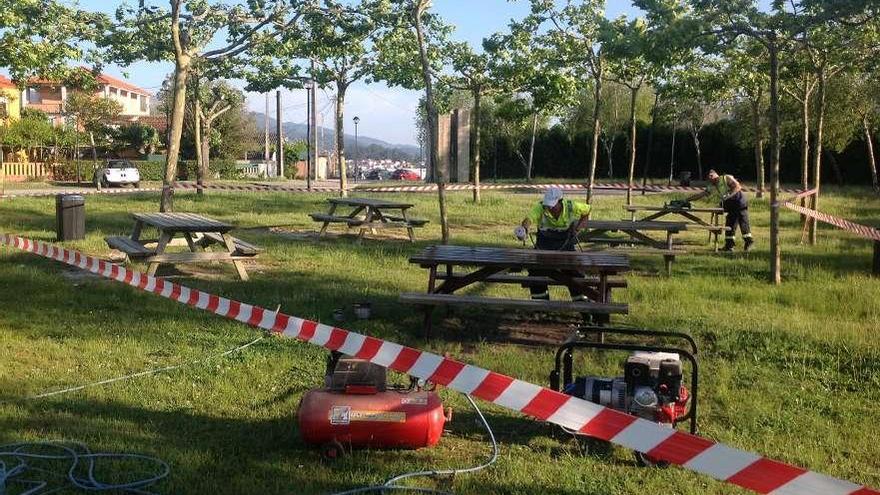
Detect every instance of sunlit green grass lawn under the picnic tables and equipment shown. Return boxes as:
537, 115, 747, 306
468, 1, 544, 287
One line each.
0, 189, 880, 495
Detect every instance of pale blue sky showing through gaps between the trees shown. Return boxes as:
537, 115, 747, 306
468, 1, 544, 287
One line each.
72, 0, 634, 144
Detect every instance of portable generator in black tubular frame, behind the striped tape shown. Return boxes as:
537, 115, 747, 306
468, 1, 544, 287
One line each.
550, 327, 699, 466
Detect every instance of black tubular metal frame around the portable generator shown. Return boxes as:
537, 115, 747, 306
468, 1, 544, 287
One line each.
550, 326, 700, 435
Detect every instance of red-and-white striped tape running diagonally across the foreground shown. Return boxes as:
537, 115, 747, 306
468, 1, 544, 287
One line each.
0, 234, 880, 495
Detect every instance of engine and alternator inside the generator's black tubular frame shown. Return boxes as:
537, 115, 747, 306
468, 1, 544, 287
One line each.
564, 351, 690, 427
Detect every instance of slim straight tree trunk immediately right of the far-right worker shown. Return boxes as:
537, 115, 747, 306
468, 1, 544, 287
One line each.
768, 41, 782, 285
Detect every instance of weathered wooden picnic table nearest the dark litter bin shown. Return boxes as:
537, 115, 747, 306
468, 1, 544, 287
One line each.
105, 213, 260, 280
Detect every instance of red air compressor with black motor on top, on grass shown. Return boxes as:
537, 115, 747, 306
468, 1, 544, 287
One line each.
297, 352, 446, 459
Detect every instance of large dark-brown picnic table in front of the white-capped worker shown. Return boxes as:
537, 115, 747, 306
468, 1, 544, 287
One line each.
400, 245, 630, 337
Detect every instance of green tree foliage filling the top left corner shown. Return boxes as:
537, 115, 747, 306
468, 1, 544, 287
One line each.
0, 0, 109, 87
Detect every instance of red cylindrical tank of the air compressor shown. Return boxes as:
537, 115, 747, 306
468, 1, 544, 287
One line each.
297, 390, 446, 449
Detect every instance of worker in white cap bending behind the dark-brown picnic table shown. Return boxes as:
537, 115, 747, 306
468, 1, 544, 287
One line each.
514, 187, 591, 301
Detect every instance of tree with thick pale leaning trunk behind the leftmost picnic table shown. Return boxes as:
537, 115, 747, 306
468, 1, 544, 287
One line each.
108, 0, 317, 211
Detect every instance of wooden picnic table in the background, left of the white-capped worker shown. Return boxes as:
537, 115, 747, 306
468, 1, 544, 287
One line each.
309, 198, 428, 242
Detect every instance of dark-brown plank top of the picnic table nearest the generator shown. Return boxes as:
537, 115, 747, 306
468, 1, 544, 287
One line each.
409, 245, 629, 273
